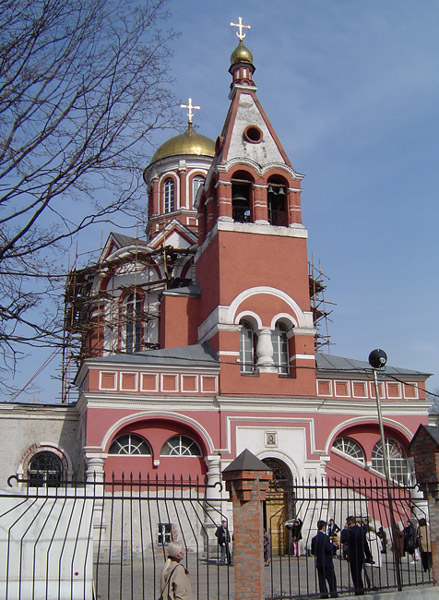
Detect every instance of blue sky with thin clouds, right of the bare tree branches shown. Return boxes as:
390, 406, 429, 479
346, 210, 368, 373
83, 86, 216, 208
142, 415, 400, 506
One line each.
6, 0, 439, 400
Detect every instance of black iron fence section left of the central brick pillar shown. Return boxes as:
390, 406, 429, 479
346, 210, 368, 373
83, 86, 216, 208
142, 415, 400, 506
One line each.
0, 477, 233, 600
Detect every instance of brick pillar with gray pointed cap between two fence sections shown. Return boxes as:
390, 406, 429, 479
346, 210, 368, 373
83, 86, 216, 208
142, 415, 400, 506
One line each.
222, 450, 273, 600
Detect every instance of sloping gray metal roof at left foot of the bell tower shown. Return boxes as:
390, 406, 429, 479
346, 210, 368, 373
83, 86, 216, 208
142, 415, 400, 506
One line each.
85, 343, 219, 369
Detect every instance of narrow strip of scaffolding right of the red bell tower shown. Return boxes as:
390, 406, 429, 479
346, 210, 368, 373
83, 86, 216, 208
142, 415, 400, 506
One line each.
308, 256, 336, 354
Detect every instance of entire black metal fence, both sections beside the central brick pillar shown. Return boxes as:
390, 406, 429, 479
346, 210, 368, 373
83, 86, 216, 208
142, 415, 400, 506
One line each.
0, 477, 432, 600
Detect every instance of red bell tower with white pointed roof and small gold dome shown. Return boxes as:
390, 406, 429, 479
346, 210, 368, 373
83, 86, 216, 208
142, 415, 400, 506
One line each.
195, 18, 315, 395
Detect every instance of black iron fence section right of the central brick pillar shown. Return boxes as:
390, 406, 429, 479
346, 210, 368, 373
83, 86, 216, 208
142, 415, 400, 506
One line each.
265, 479, 433, 599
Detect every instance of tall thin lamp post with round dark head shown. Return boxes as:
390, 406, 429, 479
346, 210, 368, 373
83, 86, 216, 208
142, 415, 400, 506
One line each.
369, 348, 402, 591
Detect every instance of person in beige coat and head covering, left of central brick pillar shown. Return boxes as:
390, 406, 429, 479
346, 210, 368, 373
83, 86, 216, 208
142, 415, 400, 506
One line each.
160, 542, 192, 600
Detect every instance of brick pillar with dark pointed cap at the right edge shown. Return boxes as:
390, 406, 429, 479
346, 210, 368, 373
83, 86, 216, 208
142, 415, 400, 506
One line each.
409, 425, 439, 585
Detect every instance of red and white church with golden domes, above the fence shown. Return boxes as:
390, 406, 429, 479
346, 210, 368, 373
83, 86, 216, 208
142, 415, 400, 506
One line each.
2, 21, 434, 536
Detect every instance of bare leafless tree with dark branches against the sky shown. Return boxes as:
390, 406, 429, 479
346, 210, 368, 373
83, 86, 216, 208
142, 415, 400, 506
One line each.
0, 0, 179, 384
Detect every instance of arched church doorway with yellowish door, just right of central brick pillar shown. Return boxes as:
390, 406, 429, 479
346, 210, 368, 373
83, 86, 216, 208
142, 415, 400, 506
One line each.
263, 458, 295, 555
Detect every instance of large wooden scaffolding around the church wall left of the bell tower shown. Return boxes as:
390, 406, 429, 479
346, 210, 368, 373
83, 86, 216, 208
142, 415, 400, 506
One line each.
61, 238, 195, 403
